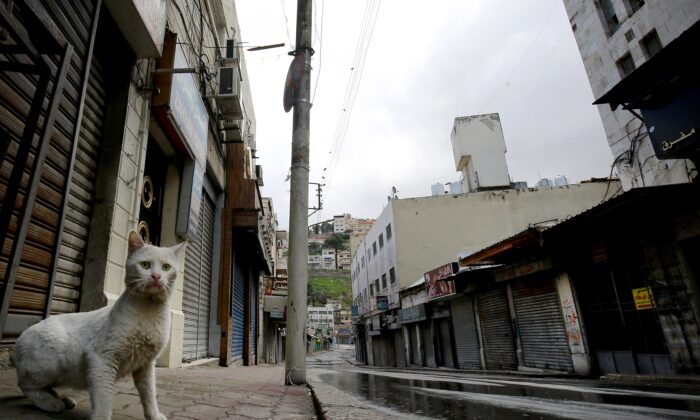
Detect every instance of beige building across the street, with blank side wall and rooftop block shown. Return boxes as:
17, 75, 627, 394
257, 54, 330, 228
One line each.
351, 115, 618, 361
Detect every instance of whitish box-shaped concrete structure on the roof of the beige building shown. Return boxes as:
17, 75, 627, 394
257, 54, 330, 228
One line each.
451, 114, 510, 192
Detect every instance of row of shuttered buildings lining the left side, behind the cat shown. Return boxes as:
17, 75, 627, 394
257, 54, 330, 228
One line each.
0, 0, 270, 367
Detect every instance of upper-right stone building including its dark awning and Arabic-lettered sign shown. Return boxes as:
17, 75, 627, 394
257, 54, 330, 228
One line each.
564, 0, 700, 191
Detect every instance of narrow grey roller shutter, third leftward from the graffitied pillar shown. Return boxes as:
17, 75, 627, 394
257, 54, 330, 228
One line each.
452, 296, 481, 369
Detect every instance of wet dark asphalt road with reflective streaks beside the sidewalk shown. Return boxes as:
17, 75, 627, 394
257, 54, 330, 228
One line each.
307, 348, 700, 420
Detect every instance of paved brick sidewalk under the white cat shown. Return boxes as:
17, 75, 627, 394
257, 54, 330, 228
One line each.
0, 364, 317, 420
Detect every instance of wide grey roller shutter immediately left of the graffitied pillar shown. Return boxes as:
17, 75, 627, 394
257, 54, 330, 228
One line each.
512, 279, 573, 371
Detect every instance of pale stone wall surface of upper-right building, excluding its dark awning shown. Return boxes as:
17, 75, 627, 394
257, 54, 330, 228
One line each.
564, 0, 700, 191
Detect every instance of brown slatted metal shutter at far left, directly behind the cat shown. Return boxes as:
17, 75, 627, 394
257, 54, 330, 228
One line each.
0, 1, 107, 342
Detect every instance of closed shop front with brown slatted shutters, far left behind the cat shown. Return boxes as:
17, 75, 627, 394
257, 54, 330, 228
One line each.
0, 1, 133, 343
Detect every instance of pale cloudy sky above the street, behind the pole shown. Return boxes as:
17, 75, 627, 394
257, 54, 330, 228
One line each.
236, 0, 612, 229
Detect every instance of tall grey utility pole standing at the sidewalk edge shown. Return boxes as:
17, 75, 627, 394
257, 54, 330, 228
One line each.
285, 0, 313, 385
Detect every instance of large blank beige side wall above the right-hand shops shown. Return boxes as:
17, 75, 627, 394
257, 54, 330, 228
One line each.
393, 182, 619, 287
